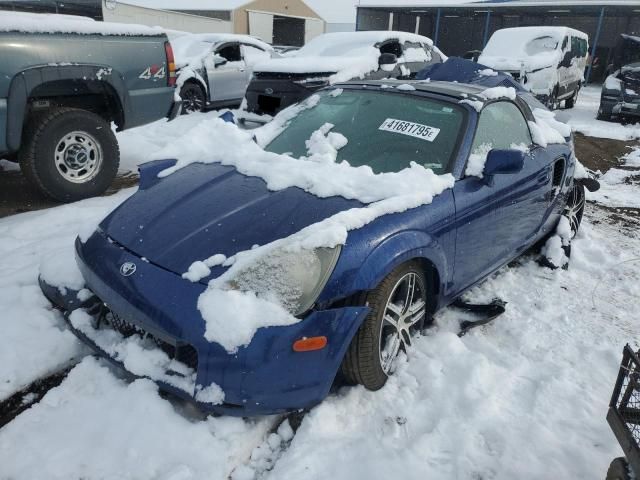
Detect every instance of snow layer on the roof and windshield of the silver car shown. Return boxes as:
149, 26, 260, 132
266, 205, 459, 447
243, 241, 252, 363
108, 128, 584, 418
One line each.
171, 33, 273, 68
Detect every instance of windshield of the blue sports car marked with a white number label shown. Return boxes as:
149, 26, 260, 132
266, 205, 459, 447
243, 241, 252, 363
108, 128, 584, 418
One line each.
266, 90, 464, 174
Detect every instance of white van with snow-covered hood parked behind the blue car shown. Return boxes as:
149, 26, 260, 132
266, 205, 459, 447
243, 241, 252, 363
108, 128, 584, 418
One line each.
478, 27, 589, 110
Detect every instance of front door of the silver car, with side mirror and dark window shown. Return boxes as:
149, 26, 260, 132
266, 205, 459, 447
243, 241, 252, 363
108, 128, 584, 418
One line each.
207, 42, 247, 102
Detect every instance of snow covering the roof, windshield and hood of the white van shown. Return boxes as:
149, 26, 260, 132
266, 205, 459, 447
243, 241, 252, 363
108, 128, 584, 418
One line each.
478, 27, 588, 70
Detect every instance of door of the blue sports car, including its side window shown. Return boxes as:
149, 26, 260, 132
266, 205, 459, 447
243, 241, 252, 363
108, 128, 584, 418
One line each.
453, 101, 550, 291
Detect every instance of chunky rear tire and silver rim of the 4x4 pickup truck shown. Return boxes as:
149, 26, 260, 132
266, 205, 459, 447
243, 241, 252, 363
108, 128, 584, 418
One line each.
18, 108, 120, 202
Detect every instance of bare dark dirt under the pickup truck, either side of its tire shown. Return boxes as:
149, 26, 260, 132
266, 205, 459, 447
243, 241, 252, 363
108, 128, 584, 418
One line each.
0, 165, 138, 218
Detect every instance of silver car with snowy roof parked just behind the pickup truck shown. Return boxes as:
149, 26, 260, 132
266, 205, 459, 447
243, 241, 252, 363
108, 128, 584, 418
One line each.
171, 33, 275, 113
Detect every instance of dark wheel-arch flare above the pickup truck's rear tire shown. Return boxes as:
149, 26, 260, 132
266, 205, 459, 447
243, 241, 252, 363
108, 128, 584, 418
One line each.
7, 64, 130, 151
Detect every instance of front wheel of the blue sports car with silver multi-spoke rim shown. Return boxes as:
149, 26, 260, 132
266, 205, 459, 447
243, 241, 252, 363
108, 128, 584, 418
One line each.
341, 261, 428, 390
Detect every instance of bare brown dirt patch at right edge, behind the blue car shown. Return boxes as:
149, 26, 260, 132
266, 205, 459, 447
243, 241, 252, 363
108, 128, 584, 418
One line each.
575, 133, 640, 173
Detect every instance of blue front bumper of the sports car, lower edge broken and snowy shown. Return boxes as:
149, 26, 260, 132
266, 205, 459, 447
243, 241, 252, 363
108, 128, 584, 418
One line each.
42, 233, 368, 416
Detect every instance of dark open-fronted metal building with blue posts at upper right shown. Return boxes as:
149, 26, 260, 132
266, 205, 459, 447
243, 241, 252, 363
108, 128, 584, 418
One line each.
356, 0, 640, 81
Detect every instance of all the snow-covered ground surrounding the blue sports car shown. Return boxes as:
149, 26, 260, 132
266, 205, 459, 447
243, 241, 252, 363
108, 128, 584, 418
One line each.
0, 89, 640, 480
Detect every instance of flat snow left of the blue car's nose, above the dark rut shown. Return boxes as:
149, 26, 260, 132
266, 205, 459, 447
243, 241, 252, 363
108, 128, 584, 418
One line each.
0, 189, 134, 402
